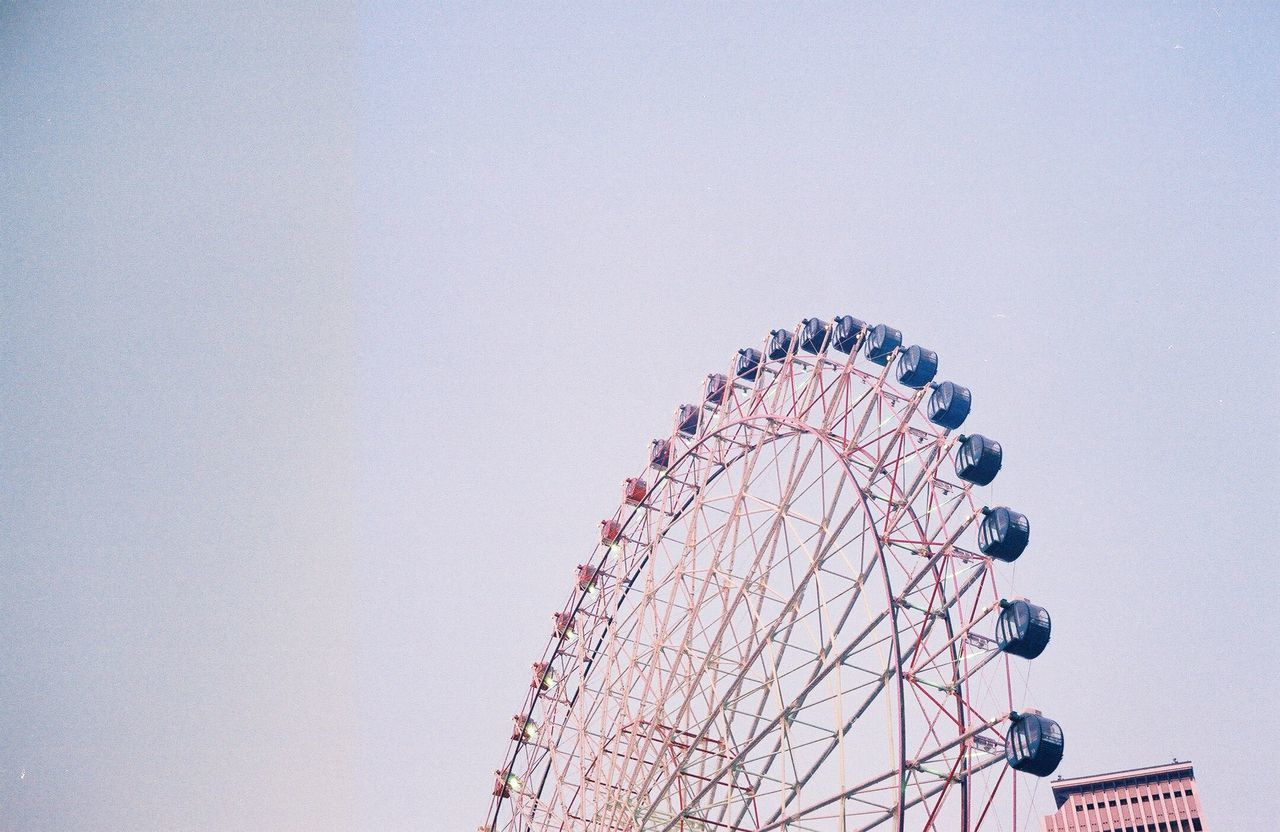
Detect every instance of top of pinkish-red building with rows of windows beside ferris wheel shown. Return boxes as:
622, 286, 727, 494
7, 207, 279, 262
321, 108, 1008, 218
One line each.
1043, 762, 1204, 832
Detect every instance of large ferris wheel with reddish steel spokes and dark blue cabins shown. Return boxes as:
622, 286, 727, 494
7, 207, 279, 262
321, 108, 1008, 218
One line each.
480, 316, 1064, 832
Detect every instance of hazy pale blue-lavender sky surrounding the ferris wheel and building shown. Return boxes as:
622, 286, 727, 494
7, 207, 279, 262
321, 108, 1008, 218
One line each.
0, 3, 1280, 831
